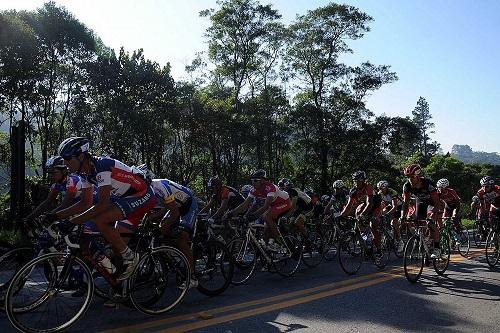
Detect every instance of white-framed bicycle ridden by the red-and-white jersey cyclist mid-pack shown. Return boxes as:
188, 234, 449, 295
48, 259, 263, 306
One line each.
228, 217, 303, 285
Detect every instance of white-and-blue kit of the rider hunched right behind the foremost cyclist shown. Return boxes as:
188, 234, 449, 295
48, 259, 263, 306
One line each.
151, 179, 198, 231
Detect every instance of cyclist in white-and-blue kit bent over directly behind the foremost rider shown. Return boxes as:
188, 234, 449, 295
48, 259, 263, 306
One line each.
146, 171, 198, 288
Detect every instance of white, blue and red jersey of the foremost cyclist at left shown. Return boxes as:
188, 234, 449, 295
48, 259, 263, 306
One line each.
81, 156, 148, 198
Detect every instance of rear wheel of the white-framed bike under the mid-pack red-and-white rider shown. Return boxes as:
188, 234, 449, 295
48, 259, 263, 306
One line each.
271, 235, 304, 277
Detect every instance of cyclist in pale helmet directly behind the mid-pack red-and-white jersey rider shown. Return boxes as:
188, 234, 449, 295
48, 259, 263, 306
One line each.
278, 178, 314, 242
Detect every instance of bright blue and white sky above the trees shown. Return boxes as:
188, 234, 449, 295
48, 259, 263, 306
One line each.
0, 0, 500, 152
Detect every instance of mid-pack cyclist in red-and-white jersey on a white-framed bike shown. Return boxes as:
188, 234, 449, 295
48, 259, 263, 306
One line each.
227, 169, 292, 250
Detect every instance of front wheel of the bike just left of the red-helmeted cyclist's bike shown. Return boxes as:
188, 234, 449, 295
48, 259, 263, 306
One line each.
339, 231, 365, 275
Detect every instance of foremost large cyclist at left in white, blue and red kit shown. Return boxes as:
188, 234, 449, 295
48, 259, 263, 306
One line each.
50, 137, 156, 281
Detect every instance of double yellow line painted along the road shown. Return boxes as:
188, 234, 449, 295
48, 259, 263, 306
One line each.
102, 252, 483, 333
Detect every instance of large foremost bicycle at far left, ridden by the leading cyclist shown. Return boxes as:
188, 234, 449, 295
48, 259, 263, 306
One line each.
5, 223, 191, 332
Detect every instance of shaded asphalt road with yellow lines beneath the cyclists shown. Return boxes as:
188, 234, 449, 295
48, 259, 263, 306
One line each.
0, 245, 500, 333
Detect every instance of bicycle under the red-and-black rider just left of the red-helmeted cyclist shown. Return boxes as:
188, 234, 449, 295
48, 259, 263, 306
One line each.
339, 217, 390, 275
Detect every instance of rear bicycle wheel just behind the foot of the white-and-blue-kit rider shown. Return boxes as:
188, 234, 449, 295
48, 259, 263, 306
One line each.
193, 241, 234, 296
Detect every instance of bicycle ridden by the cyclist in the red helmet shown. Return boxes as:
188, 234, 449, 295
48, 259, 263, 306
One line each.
403, 220, 451, 283
